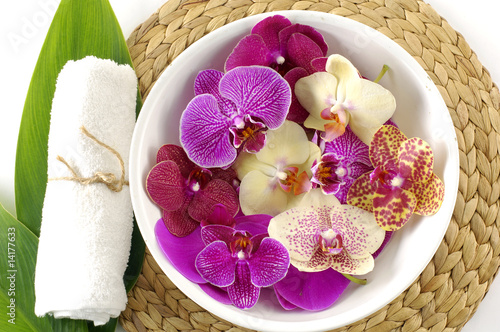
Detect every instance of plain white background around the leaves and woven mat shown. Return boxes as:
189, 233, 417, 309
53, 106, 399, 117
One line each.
0, 0, 500, 332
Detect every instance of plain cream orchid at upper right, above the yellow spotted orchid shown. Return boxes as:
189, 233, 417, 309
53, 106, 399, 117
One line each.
295, 54, 396, 145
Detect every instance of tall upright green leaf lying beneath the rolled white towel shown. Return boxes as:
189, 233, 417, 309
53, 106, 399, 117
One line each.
15, 0, 145, 331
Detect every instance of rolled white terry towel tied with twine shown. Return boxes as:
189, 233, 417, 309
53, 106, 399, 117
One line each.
35, 57, 137, 325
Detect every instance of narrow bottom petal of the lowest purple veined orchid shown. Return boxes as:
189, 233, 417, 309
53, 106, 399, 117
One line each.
227, 261, 260, 309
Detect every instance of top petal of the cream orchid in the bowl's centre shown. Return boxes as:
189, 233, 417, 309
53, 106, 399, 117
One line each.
255, 121, 310, 167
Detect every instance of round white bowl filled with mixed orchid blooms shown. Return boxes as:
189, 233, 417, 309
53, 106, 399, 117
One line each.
130, 11, 458, 331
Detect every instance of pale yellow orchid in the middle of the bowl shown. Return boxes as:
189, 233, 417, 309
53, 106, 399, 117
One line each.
233, 121, 320, 216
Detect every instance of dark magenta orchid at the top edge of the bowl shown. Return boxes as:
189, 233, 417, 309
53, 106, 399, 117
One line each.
225, 15, 328, 74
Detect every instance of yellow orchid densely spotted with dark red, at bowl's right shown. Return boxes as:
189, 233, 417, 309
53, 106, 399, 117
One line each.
347, 126, 444, 231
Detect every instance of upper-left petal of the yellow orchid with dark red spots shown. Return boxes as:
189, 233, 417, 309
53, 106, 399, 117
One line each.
370, 125, 408, 167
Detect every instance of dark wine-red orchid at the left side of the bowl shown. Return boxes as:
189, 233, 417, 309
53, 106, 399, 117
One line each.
146, 144, 239, 237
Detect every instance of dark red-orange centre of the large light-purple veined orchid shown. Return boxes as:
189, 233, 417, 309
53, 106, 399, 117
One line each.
229, 115, 267, 153
